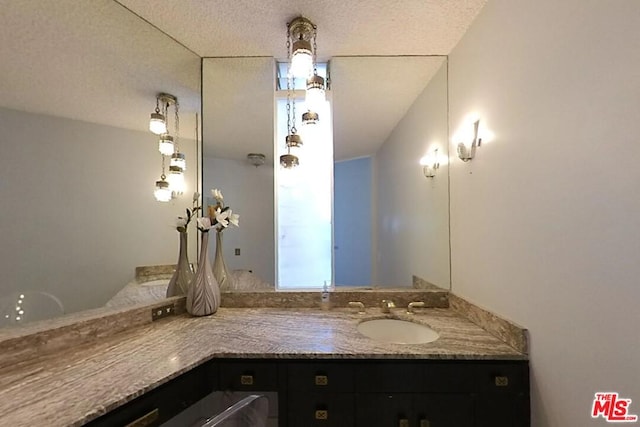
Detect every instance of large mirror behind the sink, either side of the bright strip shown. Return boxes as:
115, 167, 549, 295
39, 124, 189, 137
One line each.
202, 56, 450, 289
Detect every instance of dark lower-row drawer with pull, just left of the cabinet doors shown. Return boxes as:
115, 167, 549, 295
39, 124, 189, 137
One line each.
288, 392, 355, 427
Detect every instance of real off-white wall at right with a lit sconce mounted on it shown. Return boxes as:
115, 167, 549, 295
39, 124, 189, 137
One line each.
449, 0, 640, 427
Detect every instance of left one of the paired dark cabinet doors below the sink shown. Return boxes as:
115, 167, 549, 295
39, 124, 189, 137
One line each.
355, 393, 415, 427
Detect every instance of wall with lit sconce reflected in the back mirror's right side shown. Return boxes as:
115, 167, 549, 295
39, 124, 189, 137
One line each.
374, 63, 450, 288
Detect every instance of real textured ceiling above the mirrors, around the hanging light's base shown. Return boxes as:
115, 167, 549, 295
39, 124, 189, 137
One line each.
118, 0, 486, 59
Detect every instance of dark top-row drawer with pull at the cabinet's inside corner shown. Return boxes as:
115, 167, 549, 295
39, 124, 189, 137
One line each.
219, 361, 278, 391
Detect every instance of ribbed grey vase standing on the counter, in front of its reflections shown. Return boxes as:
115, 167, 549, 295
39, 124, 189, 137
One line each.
186, 231, 220, 316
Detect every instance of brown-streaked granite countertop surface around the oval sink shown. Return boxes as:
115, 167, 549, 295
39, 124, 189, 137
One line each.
0, 308, 527, 427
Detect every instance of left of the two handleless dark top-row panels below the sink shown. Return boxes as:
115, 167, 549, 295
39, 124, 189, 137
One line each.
355, 361, 424, 393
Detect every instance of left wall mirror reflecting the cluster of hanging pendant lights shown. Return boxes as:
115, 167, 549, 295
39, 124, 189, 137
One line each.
0, 0, 200, 327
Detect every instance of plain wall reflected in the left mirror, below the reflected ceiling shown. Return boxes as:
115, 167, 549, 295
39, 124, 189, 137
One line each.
0, 105, 197, 312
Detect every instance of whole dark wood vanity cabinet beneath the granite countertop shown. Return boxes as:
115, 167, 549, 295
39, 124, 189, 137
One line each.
91, 359, 530, 427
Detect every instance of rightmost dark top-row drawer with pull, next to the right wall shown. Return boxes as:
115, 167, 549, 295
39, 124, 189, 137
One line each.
476, 363, 529, 392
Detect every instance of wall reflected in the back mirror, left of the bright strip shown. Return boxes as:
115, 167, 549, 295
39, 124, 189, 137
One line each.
203, 157, 275, 283
